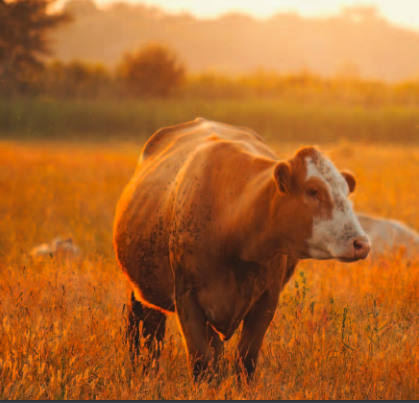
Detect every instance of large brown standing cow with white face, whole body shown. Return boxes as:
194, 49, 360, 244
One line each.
113, 118, 370, 381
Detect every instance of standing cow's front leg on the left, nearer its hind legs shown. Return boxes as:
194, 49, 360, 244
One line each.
175, 281, 222, 381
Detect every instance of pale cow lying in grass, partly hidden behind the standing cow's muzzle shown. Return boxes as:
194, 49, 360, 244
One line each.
356, 213, 419, 256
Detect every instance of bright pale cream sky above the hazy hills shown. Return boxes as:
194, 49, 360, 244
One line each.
83, 0, 419, 30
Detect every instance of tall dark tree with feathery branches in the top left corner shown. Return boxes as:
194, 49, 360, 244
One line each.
0, 0, 71, 92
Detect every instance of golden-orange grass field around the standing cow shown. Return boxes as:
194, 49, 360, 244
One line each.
0, 137, 419, 399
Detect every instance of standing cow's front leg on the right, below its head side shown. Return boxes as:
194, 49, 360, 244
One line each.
237, 291, 279, 382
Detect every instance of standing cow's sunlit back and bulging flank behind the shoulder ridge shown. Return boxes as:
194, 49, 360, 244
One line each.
114, 118, 275, 310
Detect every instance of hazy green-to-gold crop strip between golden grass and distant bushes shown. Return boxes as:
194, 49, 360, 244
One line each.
0, 98, 419, 144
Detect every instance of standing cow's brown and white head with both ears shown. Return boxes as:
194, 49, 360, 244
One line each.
274, 147, 371, 262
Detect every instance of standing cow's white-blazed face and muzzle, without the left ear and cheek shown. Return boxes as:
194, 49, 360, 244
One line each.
304, 153, 371, 262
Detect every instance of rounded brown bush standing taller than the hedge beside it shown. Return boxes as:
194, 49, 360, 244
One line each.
118, 44, 185, 97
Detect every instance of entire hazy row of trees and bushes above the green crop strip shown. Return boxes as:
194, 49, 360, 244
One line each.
0, 0, 419, 106
